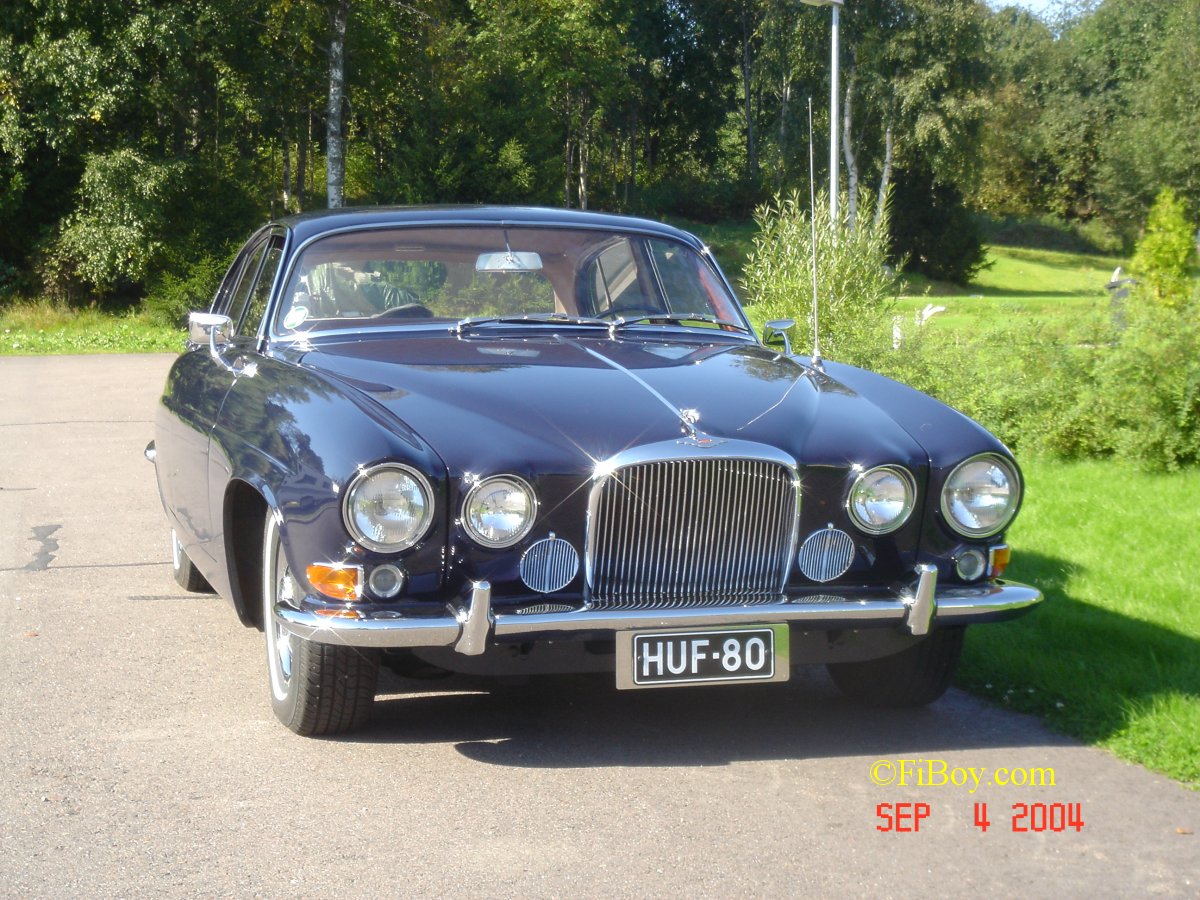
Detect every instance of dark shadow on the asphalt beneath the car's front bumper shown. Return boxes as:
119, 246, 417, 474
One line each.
340, 667, 1074, 768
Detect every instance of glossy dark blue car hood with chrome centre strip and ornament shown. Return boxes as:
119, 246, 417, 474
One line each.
300, 331, 928, 476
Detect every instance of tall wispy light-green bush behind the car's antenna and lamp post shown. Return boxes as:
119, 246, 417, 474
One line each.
742, 193, 899, 366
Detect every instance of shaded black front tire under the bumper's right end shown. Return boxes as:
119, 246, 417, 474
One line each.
826, 628, 966, 707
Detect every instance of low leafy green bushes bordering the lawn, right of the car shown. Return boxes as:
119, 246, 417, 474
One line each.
876, 288, 1200, 470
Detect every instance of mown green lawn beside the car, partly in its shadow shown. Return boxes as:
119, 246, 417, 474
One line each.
959, 460, 1200, 788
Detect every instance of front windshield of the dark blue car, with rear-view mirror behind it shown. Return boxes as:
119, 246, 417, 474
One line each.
275, 226, 744, 335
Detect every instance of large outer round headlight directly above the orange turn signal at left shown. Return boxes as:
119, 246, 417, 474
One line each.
342, 463, 433, 553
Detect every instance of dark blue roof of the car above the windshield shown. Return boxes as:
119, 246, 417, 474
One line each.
272, 206, 703, 250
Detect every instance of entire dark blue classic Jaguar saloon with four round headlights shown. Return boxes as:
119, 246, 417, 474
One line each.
146, 208, 1042, 734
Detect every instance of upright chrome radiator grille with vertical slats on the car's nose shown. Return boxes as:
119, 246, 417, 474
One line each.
587, 458, 798, 608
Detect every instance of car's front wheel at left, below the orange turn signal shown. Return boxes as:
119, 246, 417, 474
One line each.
263, 514, 379, 736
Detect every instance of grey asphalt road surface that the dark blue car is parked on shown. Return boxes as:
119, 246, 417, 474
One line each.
0, 356, 1200, 896
